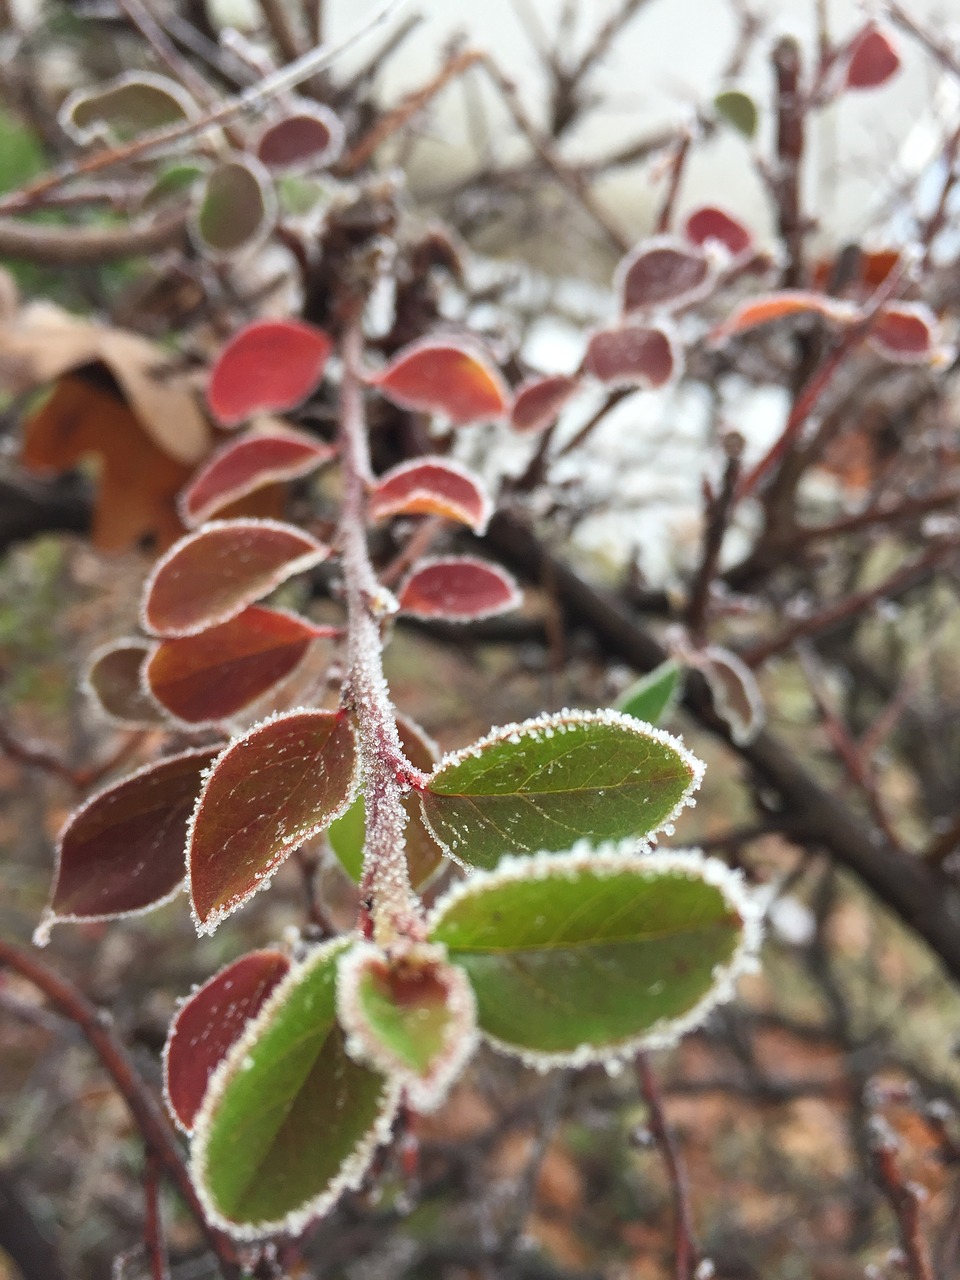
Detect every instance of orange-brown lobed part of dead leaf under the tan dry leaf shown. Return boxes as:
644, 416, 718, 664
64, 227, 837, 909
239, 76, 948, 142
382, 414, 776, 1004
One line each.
20, 374, 189, 552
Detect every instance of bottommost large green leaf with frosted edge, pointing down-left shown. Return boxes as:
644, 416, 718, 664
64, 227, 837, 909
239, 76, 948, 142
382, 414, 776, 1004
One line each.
191, 938, 399, 1239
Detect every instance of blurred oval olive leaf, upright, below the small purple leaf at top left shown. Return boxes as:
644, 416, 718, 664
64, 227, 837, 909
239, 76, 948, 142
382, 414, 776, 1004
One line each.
192, 155, 278, 259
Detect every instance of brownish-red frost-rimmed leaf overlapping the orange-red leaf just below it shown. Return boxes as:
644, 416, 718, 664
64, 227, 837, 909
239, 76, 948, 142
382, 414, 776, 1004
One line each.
141, 520, 329, 636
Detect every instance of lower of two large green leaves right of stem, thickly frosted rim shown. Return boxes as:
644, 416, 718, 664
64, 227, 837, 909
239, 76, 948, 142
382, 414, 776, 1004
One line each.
428, 847, 760, 1071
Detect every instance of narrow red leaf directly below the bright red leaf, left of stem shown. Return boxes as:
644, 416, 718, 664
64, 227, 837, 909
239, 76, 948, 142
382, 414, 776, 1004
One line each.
178, 431, 337, 529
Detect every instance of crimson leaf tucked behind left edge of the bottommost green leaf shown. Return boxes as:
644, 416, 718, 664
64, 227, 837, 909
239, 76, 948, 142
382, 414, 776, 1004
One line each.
164, 951, 291, 1133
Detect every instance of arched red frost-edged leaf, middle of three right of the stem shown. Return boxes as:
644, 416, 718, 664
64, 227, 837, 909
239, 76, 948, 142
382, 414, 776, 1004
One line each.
370, 458, 493, 534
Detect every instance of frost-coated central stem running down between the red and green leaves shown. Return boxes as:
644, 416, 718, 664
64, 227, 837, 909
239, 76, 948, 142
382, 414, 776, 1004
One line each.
339, 325, 425, 945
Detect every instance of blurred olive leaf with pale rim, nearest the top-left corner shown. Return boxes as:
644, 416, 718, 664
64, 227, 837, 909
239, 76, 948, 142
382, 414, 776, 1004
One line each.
58, 72, 198, 146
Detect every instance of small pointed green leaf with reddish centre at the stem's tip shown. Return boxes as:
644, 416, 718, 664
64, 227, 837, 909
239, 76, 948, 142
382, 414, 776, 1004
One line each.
337, 942, 476, 1112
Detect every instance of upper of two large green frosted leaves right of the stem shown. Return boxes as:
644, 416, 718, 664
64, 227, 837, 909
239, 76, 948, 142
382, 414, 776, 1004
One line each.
420, 710, 703, 869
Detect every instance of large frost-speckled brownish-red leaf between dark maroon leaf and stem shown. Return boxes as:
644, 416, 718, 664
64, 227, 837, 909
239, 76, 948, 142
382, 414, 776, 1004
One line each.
187, 710, 356, 933
